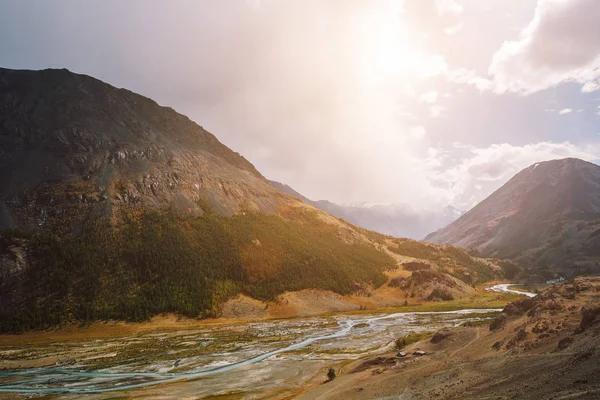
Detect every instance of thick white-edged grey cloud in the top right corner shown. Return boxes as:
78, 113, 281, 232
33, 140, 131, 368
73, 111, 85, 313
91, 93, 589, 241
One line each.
488, 0, 600, 94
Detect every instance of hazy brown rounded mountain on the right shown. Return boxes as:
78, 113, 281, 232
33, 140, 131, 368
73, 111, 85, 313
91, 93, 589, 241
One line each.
425, 158, 600, 275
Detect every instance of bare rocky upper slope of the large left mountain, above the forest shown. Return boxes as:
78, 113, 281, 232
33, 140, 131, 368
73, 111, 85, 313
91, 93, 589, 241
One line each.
0, 69, 279, 230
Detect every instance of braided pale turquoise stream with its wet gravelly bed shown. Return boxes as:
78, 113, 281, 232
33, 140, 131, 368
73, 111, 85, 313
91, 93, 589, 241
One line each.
0, 285, 535, 398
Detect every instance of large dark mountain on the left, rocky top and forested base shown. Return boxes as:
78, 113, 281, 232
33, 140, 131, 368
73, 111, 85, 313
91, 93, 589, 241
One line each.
0, 69, 504, 332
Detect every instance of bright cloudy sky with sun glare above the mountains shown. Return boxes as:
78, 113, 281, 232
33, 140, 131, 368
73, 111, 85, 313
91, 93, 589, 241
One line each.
0, 0, 600, 210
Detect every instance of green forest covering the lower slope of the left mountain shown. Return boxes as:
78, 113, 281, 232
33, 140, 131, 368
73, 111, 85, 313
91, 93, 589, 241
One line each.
0, 210, 395, 333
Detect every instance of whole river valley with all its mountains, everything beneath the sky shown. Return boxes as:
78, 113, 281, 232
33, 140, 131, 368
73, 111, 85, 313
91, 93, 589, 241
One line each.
0, 68, 600, 400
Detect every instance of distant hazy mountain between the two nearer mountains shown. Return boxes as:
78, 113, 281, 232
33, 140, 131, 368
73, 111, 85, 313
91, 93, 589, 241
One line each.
269, 181, 462, 239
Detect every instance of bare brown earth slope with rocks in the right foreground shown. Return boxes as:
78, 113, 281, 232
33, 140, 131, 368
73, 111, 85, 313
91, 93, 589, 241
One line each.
299, 277, 600, 400
